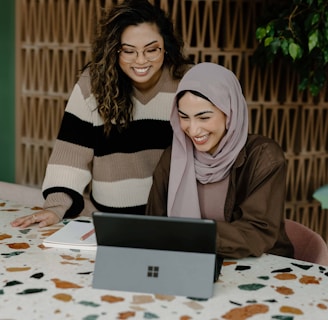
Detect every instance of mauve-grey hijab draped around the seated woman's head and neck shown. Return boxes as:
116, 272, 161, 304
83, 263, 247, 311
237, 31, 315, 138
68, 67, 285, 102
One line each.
167, 62, 248, 218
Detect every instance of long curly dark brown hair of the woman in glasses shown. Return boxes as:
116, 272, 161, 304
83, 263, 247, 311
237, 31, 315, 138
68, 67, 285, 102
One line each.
87, 0, 191, 135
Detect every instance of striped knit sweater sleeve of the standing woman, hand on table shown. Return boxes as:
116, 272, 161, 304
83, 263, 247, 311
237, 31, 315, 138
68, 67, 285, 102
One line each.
42, 79, 100, 217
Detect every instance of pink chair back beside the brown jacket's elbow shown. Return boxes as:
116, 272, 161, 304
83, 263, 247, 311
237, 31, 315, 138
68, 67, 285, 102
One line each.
285, 219, 328, 266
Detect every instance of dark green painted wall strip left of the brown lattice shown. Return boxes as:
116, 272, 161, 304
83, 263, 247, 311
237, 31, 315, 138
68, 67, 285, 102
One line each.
0, 0, 15, 182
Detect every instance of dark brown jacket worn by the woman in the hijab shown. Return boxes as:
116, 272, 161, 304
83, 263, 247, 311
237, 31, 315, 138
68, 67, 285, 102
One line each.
146, 135, 293, 258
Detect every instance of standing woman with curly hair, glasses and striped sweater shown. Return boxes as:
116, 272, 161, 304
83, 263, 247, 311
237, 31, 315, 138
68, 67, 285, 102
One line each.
12, 0, 190, 227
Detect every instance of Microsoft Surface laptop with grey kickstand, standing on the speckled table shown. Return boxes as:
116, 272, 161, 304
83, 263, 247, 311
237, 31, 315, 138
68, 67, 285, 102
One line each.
92, 212, 222, 299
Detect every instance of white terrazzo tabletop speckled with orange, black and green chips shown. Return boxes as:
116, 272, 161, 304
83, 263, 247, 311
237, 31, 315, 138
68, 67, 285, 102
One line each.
0, 200, 328, 320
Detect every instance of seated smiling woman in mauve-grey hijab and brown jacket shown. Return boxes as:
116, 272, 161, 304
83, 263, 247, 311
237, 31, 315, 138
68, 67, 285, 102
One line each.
146, 62, 293, 258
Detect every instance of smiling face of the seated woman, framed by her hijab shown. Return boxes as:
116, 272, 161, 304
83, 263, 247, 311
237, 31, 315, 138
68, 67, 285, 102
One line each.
178, 92, 227, 154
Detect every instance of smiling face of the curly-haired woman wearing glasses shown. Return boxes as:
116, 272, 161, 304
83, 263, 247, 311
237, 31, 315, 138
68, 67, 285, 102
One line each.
119, 23, 165, 90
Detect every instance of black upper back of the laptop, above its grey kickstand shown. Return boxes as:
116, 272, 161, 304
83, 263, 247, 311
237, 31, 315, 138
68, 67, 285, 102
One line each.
93, 212, 216, 253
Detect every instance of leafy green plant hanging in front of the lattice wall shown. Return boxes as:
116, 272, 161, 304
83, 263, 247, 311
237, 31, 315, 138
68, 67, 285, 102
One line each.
254, 0, 328, 96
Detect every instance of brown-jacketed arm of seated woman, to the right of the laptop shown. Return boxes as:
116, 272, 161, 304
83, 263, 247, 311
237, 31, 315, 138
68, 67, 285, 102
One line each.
217, 139, 289, 258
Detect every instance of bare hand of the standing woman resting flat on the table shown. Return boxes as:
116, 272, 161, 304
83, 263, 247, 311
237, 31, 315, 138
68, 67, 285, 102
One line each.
11, 210, 60, 228
